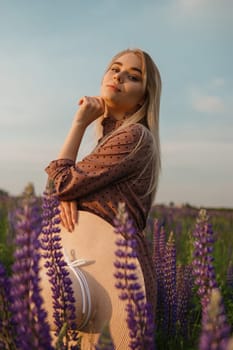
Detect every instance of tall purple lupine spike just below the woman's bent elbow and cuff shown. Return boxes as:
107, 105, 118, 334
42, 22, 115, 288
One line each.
40, 183, 77, 345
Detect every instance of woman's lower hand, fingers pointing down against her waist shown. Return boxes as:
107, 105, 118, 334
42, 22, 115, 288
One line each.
60, 201, 78, 232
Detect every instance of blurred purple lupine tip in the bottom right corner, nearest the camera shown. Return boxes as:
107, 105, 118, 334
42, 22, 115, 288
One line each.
199, 288, 230, 350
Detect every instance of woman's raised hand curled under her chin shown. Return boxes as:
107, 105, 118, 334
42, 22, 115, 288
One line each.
74, 96, 105, 127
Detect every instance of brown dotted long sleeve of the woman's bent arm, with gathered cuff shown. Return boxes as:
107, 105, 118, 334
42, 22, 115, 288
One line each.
46, 124, 151, 200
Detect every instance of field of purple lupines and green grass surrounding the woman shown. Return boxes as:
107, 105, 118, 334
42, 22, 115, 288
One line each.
0, 185, 233, 350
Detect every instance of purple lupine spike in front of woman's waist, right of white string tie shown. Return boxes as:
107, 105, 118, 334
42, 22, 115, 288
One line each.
114, 203, 155, 350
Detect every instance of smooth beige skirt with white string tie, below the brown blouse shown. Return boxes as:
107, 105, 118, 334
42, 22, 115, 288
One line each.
41, 211, 145, 350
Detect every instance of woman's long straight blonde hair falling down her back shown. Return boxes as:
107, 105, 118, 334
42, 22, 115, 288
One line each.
97, 49, 162, 201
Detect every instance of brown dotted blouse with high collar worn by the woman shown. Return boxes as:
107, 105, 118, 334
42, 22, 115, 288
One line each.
46, 117, 155, 312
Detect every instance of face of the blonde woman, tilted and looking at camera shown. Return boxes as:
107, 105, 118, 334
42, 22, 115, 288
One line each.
101, 52, 145, 118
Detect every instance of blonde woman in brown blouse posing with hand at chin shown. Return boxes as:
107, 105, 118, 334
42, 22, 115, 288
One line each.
43, 49, 161, 349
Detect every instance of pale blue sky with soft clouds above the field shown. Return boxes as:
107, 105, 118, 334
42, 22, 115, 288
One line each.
0, 0, 233, 208
